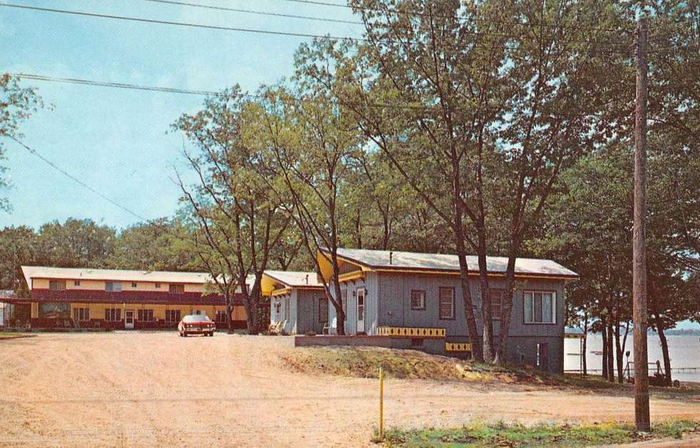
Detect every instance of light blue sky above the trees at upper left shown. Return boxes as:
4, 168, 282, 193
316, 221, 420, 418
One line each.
0, 0, 362, 229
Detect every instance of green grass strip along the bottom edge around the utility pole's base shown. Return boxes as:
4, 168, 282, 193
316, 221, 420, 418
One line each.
373, 420, 700, 448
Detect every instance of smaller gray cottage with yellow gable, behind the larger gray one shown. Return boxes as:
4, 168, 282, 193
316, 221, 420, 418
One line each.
261, 270, 328, 334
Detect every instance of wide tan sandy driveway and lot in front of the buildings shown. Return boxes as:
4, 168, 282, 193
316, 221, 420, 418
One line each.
0, 332, 700, 447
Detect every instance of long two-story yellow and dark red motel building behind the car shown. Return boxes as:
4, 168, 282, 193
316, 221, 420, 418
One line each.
6, 266, 246, 329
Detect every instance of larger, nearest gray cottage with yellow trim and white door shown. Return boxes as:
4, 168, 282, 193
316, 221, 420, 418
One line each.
318, 249, 578, 373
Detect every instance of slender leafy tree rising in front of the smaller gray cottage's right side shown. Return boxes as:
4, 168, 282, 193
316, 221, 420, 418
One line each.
250, 83, 361, 335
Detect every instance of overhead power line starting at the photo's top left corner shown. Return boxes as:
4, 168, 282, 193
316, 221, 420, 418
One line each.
0, 3, 367, 42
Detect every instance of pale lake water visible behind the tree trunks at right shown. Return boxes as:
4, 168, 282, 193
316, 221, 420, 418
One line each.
564, 330, 700, 382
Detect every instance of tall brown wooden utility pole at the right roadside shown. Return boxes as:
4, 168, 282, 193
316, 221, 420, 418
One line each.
632, 10, 651, 432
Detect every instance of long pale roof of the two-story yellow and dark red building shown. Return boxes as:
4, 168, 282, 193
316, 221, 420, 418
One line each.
22, 266, 212, 288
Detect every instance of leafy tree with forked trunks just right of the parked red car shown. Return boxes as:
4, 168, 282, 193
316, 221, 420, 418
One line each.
174, 87, 290, 333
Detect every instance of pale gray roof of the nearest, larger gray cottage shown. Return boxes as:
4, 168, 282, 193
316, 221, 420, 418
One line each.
330, 249, 578, 277
